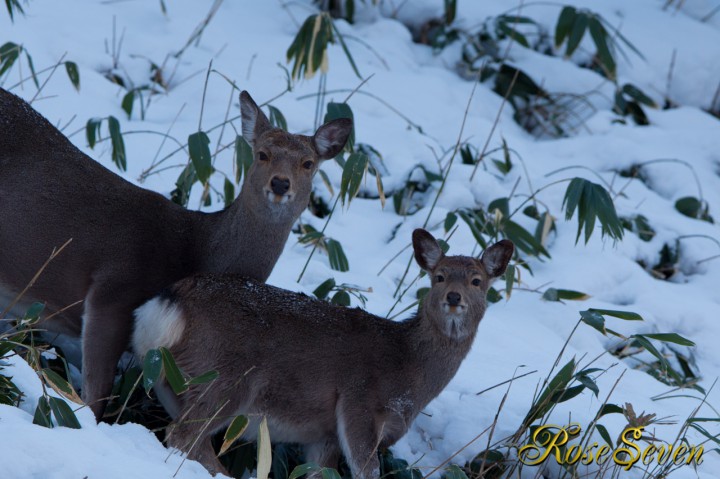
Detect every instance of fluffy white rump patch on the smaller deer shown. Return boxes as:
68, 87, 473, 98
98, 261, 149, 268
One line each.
132, 298, 185, 358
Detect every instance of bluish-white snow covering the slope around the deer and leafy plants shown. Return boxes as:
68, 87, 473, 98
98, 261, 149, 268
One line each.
0, 0, 720, 478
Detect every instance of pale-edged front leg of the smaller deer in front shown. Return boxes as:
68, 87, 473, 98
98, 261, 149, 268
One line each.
336, 401, 380, 479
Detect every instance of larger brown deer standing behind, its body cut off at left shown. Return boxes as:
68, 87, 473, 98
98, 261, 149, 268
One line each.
0, 89, 352, 418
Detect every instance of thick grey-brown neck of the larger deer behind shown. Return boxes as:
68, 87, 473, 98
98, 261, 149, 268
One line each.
199, 188, 295, 282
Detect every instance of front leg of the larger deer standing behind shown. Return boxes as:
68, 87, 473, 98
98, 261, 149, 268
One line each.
82, 289, 135, 421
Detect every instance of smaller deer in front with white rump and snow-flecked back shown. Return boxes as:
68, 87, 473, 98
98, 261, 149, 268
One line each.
133, 229, 514, 479
